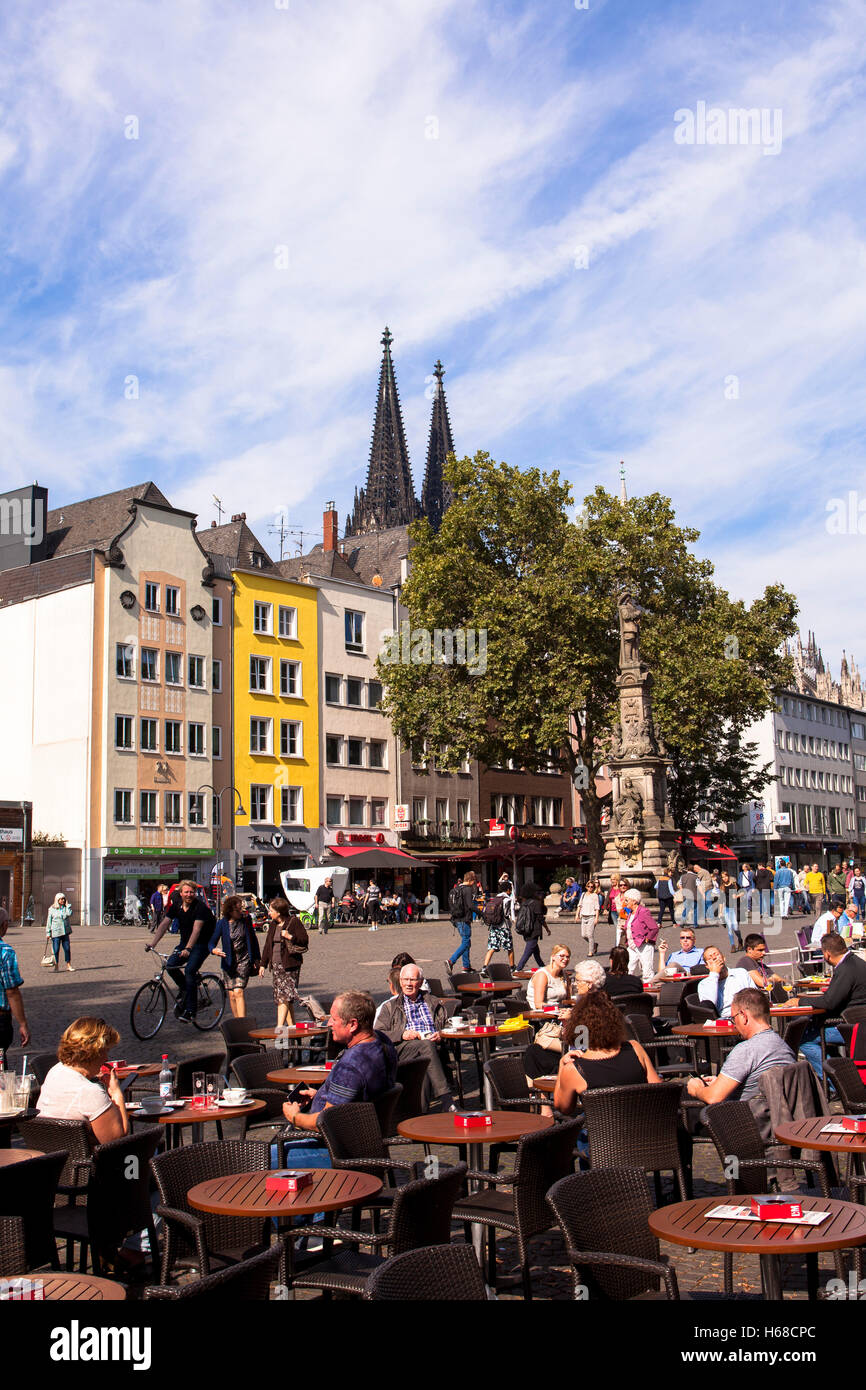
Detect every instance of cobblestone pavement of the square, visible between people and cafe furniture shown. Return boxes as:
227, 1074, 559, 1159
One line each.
1, 917, 835, 1300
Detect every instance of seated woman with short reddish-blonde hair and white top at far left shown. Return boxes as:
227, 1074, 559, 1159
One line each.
36, 1019, 129, 1144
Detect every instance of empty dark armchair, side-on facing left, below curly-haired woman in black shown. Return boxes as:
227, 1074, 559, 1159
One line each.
455, 1120, 581, 1300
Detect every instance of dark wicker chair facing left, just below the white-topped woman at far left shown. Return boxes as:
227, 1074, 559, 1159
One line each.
54, 1125, 162, 1275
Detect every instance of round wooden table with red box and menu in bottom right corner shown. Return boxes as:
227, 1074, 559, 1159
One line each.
649, 1195, 866, 1301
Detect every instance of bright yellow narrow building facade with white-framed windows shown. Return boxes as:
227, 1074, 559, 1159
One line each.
227, 569, 322, 898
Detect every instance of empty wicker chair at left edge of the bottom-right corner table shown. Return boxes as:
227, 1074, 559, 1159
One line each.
548, 1168, 680, 1301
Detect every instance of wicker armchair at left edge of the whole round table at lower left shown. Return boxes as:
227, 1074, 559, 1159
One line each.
150, 1140, 271, 1284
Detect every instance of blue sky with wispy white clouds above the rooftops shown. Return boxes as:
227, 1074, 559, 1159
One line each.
0, 0, 866, 671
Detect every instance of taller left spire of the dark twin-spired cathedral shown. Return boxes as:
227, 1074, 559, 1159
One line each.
346, 327, 418, 535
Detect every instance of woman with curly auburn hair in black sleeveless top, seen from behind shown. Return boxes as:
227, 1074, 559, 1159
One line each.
553, 990, 662, 1117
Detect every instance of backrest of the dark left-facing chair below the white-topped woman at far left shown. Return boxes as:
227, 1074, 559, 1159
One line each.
88, 1125, 163, 1254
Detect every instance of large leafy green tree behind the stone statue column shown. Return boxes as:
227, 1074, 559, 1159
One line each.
378, 453, 795, 867
